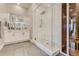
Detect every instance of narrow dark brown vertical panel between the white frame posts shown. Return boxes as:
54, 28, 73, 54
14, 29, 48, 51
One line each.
62, 3, 67, 53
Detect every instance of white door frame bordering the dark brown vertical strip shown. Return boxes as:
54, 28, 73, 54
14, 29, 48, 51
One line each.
60, 3, 69, 56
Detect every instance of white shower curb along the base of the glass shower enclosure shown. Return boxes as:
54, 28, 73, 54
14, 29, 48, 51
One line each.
31, 40, 60, 56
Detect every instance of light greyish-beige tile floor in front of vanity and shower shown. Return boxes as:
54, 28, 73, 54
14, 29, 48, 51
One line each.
0, 42, 48, 56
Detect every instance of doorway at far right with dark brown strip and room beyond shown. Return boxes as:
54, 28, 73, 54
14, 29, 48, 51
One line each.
61, 3, 79, 56
